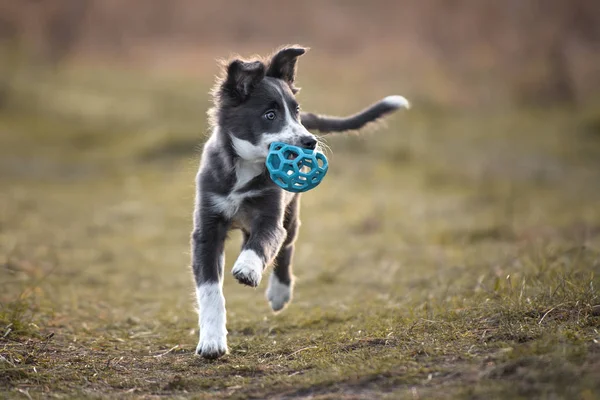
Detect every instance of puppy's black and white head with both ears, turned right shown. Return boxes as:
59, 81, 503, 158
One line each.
212, 46, 317, 162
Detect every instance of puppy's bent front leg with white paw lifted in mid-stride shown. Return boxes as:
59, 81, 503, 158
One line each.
231, 206, 286, 287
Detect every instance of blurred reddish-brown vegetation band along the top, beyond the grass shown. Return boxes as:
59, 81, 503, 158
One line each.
0, 0, 600, 108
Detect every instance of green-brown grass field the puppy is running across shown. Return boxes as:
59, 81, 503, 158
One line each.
0, 66, 600, 399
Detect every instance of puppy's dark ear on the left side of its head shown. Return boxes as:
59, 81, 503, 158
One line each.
221, 59, 265, 103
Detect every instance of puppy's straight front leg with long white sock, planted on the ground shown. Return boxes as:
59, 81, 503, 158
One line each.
192, 209, 228, 358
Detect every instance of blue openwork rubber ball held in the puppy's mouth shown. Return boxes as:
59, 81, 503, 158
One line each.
266, 142, 329, 193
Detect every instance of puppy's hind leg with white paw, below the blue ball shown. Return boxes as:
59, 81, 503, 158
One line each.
265, 195, 300, 312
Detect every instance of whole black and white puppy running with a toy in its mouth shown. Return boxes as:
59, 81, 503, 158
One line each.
191, 46, 408, 358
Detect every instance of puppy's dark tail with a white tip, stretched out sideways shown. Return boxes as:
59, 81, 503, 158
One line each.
300, 96, 410, 133
